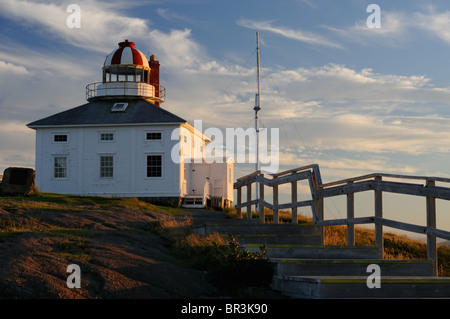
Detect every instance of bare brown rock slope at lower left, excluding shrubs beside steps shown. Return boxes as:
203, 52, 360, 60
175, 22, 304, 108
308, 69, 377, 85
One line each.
0, 194, 215, 299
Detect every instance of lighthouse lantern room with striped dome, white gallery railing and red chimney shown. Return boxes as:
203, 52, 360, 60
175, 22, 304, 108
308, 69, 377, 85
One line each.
86, 40, 165, 106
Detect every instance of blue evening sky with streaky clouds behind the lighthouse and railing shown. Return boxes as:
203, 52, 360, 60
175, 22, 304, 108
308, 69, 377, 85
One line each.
0, 0, 450, 239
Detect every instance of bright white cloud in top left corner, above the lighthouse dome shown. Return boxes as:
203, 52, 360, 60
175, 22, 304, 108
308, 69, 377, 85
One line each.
0, 0, 148, 52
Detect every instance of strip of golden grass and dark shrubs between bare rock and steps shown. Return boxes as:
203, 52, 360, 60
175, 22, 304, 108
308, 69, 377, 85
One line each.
151, 211, 273, 296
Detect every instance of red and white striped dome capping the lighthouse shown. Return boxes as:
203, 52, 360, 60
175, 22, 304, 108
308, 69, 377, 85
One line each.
103, 40, 149, 68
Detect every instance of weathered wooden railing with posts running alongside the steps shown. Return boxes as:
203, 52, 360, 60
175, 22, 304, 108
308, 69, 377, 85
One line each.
234, 164, 450, 275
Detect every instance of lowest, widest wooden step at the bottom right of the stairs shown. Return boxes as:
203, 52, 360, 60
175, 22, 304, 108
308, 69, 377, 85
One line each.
272, 275, 450, 299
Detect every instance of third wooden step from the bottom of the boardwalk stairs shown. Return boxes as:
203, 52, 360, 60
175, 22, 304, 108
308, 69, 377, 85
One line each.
245, 244, 379, 259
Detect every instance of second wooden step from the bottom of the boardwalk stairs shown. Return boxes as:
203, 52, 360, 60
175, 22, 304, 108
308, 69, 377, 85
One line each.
271, 258, 433, 277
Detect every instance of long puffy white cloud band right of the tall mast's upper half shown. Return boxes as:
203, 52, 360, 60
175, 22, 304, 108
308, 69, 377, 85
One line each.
263, 64, 444, 110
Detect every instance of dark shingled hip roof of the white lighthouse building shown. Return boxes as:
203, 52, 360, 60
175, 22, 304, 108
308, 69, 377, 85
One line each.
27, 99, 187, 129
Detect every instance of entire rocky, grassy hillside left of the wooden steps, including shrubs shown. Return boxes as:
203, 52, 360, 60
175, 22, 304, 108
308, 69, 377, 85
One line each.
0, 193, 279, 299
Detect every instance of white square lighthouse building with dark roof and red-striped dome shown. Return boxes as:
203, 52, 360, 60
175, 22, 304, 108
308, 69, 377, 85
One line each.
27, 40, 234, 207
